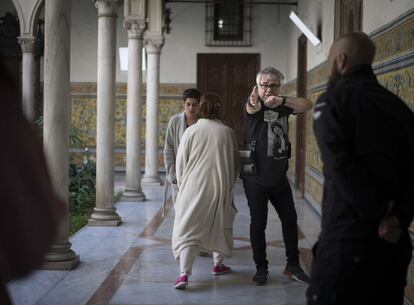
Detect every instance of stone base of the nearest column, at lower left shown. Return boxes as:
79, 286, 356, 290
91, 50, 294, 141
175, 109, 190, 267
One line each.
41, 242, 79, 270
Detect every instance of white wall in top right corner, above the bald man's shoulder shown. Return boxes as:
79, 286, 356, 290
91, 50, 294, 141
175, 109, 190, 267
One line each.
362, 0, 414, 34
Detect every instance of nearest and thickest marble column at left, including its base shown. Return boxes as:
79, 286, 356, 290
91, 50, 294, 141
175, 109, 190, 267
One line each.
43, 0, 79, 270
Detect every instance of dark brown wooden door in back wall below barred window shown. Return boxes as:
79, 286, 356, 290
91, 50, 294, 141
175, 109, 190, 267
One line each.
197, 54, 260, 145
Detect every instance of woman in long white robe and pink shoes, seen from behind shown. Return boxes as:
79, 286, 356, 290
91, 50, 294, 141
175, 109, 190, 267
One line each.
172, 93, 239, 288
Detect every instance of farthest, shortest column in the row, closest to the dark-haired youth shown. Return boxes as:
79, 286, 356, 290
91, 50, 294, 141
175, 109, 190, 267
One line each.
142, 35, 164, 185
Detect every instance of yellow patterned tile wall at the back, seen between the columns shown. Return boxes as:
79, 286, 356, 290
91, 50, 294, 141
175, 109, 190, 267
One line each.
71, 83, 195, 168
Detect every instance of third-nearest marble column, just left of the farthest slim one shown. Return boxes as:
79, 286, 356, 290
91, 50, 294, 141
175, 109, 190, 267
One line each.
123, 19, 145, 201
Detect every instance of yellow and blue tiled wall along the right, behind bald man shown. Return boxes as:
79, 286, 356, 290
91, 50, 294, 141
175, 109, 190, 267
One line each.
286, 10, 414, 302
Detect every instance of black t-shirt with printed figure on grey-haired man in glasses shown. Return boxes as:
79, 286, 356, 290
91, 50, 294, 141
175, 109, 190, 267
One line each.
242, 101, 293, 186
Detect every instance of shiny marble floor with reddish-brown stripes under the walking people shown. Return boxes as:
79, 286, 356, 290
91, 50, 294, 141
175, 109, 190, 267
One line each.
8, 176, 320, 305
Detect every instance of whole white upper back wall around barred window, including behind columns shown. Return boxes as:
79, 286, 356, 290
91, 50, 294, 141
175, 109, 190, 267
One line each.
71, 0, 292, 83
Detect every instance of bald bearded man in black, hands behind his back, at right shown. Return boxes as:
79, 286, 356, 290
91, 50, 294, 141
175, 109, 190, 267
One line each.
307, 33, 414, 305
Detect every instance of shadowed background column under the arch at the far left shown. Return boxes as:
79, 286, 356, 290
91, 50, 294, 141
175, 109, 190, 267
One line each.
19, 34, 36, 123
